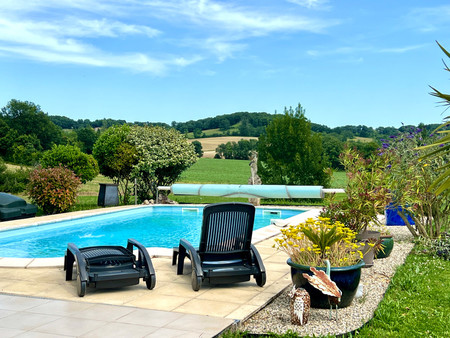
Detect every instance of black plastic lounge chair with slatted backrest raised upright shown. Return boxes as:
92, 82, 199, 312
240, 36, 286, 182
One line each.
172, 203, 266, 291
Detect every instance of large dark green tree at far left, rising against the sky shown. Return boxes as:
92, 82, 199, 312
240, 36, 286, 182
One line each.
1, 100, 62, 150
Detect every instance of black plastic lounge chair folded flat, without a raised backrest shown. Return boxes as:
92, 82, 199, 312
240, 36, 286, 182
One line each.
64, 239, 156, 297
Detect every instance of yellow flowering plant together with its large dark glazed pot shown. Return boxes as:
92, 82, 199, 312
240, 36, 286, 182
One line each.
275, 217, 364, 308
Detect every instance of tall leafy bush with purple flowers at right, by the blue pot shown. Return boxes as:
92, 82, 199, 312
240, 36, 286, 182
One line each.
383, 127, 450, 238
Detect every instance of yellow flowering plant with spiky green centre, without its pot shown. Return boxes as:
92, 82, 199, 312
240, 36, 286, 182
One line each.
275, 217, 363, 267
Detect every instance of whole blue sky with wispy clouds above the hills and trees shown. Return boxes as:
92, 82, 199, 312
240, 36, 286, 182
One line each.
0, 0, 450, 127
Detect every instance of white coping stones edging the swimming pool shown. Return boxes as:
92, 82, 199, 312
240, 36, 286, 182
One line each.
0, 204, 320, 269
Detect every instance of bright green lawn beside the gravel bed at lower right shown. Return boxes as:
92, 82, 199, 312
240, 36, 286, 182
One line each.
221, 253, 450, 338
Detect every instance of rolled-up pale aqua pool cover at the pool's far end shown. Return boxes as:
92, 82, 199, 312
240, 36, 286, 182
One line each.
171, 184, 325, 198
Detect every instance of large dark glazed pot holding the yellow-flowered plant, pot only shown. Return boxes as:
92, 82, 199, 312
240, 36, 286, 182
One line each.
287, 258, 364, 309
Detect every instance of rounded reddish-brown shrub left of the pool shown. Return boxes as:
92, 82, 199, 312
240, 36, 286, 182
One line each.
28, 166, 81, 214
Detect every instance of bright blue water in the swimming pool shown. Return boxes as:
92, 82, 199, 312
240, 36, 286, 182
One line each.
0, 206, 303, 258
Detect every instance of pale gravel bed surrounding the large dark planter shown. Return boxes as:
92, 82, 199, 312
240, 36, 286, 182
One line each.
238, 226, 413, 336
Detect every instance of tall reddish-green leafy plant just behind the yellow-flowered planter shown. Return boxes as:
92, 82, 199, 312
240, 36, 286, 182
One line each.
321, 148, 391, 266
